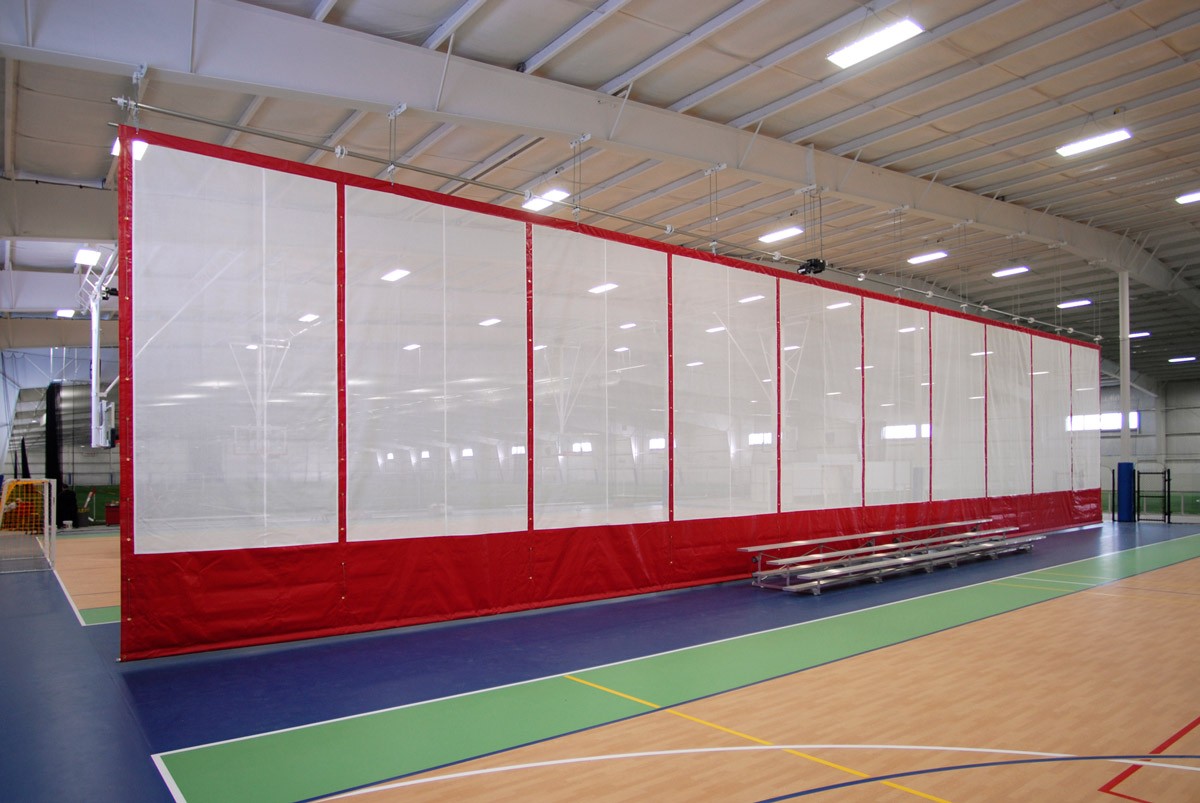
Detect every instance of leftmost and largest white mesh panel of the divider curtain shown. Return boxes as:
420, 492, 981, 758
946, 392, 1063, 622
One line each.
132, 148, 337, 552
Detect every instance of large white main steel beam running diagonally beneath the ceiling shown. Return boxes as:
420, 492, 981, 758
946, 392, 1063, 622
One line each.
0, 0, 1200, 307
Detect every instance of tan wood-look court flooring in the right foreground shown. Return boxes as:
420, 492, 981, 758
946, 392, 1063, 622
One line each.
336, 559, 1200, 803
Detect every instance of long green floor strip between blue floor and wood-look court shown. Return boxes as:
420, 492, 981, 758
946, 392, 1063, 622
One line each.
158, 534, 1200, 803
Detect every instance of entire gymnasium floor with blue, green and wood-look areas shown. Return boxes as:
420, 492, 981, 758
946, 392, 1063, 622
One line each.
0, 522, 1200, 803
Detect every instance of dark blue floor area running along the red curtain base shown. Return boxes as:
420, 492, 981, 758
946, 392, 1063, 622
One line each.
0, 522, 1200, 802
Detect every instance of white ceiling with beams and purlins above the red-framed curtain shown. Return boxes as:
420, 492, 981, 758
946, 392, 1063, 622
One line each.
0, 0, 1200, 389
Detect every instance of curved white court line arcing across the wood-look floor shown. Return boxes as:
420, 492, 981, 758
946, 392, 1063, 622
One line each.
318, 744, 1200, 801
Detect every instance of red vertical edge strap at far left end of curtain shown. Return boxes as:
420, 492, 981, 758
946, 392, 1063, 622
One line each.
116, 126, 134, 643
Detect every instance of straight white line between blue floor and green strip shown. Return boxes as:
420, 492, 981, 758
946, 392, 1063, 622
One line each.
151, 525, 1200, 801
